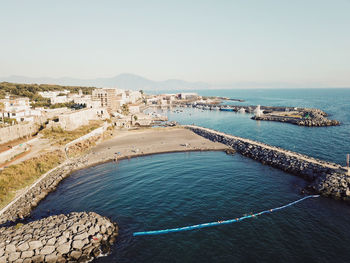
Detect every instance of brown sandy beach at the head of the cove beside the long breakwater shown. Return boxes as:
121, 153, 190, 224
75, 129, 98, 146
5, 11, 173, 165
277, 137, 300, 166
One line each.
84, 127, 228, 166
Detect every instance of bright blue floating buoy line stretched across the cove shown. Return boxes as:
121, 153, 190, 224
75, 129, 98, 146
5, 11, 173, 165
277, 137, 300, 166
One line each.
133, 195, 319, 237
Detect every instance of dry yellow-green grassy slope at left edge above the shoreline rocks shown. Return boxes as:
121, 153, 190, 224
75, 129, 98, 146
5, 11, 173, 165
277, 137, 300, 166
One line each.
0, 150, 65, 207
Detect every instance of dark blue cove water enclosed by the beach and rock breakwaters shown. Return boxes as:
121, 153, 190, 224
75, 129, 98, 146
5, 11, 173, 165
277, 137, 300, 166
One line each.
32, 152, 350, 262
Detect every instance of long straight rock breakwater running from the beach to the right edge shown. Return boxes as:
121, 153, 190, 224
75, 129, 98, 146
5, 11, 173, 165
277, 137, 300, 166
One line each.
185, 125, 350, 201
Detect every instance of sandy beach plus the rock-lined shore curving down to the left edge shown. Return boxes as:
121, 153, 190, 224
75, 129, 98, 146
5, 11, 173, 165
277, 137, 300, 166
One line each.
0, 127, 228, 225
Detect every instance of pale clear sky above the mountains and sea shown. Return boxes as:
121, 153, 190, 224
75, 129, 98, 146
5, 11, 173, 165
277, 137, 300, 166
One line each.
0, 0, 350, 87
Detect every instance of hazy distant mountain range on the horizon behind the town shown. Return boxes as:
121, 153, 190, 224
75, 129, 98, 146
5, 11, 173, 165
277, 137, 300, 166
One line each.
0, 73, 211, 90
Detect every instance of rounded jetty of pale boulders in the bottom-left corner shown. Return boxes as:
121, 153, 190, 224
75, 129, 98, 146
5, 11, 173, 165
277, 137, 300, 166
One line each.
0, 212, 118, 263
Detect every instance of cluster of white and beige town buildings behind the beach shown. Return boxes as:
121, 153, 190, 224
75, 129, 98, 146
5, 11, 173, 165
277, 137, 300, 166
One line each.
0, 88, 198, 130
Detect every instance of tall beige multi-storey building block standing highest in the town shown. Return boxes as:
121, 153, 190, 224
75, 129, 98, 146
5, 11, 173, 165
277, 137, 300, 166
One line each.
92, 89, 120, 112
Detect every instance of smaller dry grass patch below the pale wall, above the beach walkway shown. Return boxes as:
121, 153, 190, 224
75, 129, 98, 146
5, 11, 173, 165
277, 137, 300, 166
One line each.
41, 121, 103, 145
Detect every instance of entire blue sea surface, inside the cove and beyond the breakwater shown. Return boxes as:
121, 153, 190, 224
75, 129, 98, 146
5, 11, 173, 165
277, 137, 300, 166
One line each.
32, 89, 350, 262
